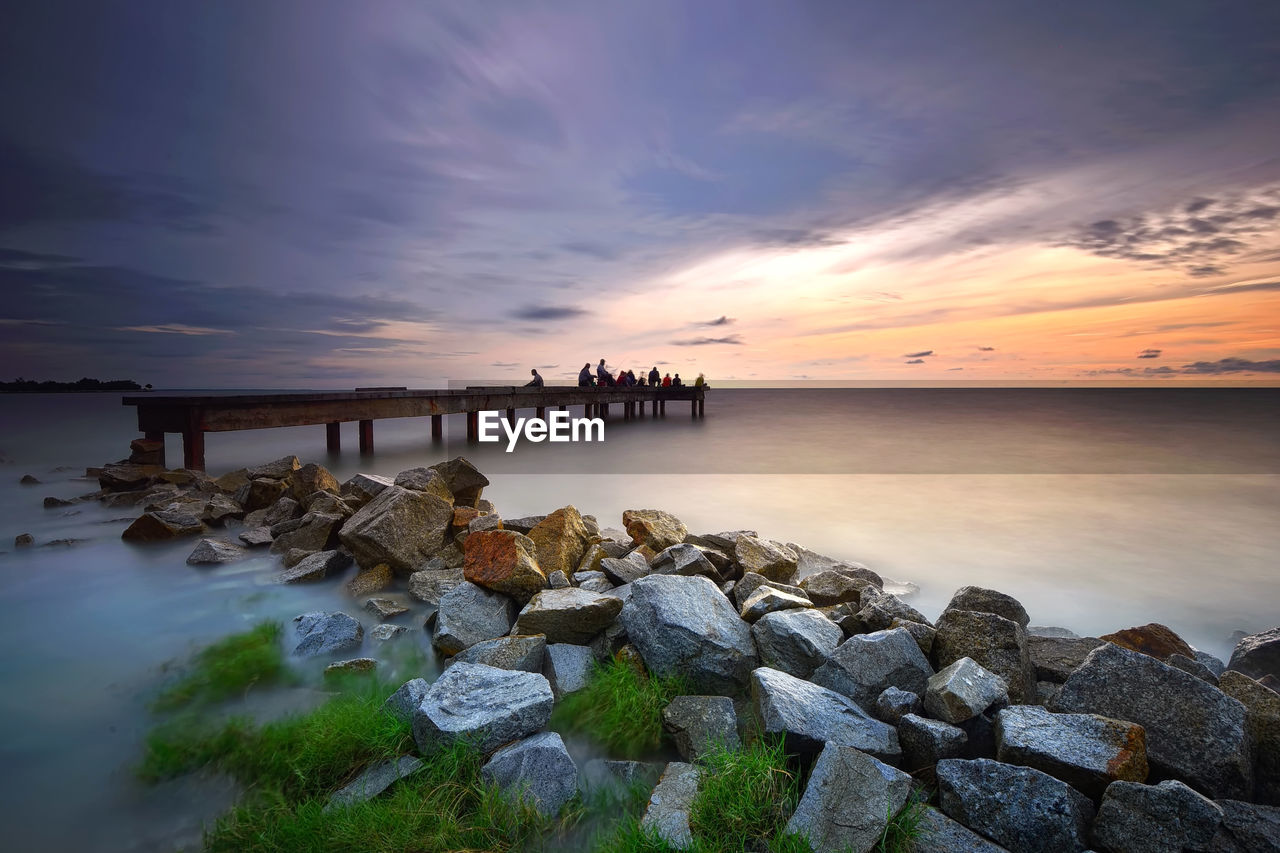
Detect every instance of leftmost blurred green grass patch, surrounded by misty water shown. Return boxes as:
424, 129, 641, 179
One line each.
151, 622, 289, 711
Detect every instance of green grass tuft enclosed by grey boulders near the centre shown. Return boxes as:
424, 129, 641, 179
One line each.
550, 661, 689, 758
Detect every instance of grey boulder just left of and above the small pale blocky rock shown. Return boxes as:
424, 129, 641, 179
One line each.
813, 628, 933, 711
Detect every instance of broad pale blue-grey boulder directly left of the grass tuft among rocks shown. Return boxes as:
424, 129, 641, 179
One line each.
413, 663, 556, 753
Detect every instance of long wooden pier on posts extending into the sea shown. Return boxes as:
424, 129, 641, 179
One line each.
123, 386, 705, 470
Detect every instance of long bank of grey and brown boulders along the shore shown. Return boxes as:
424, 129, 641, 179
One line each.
22, 441, 1280, 853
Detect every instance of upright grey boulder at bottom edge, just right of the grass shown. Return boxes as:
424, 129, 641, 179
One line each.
783, 743, 911, 853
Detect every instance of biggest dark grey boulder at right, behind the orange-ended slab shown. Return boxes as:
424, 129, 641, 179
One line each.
1050, 643, 1253, 797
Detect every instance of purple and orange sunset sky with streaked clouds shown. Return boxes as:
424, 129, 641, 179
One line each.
0, 0, 1280, 388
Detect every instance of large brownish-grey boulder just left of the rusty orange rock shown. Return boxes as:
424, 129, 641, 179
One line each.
338, 485, 453, 575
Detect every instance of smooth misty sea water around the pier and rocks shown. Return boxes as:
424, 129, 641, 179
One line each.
0, 388, 1280, 850
